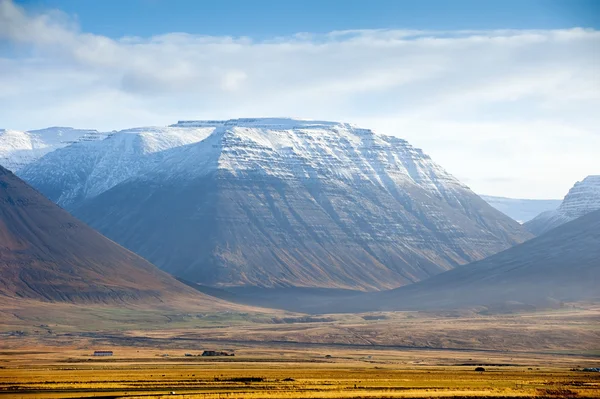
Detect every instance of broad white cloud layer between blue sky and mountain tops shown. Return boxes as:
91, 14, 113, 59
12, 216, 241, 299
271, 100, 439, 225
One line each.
0, 0, 600, 198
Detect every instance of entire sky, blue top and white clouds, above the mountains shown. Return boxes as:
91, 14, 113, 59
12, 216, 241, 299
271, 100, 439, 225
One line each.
0, 0, 600, 198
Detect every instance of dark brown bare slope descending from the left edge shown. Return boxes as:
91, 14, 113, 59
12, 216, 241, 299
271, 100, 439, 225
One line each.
0, 166, 223, 303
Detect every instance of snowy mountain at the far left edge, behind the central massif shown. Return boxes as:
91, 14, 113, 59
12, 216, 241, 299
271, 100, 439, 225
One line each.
0, 127, 106, 172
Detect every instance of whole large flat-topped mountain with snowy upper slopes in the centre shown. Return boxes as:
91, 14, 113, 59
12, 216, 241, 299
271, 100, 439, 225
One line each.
21, 118, 531, 289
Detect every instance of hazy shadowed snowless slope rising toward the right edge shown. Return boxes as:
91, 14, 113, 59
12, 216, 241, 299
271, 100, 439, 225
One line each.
328, 211, 600, 312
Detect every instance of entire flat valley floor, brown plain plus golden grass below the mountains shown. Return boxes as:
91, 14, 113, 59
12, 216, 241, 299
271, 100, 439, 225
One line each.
0, 304, 600, 398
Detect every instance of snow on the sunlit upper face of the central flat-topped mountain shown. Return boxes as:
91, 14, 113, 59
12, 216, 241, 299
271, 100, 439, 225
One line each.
165, 118, 466, 202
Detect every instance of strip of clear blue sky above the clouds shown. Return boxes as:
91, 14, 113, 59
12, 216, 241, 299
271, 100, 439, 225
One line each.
17, 0, 600, 38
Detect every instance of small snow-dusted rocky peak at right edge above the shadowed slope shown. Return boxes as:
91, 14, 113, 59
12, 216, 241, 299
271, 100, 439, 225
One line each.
524, 175, 600, 235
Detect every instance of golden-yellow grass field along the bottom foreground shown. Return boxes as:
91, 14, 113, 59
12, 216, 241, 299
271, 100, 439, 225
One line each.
0, 341, 600, 399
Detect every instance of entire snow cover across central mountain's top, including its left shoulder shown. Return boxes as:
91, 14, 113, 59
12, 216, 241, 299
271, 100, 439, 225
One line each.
18, 118, 468, 207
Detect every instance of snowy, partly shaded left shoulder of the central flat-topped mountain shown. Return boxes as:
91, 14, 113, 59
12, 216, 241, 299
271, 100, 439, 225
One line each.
17, 127, 212, 209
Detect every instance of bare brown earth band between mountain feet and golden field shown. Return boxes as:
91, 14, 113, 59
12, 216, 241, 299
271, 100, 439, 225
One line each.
0, 301, 600, 362
